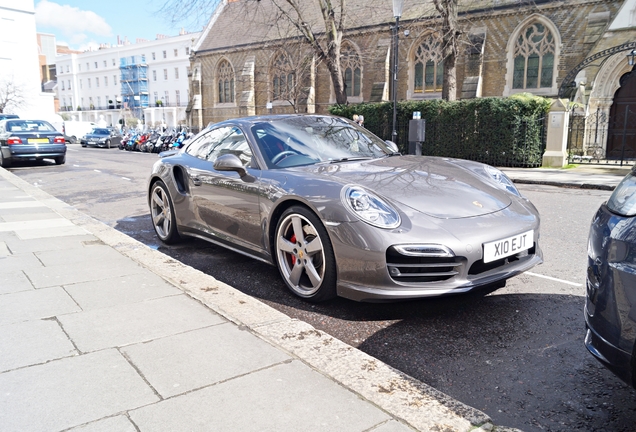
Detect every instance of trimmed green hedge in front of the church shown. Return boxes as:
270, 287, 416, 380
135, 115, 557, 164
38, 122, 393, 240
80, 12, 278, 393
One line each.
330, 94, 551, 167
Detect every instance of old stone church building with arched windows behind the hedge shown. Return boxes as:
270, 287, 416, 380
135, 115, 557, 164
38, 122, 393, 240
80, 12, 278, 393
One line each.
188, 0, 636, 159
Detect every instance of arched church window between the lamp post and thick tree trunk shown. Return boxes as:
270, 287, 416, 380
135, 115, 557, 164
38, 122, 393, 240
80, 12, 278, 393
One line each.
413, 35, 444, 93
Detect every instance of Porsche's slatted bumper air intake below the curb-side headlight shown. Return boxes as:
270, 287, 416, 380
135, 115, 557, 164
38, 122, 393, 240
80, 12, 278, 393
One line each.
386, 247, 463, 282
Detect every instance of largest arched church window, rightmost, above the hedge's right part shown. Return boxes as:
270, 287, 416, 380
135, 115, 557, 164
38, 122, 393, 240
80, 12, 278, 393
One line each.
512, 22, 555, 89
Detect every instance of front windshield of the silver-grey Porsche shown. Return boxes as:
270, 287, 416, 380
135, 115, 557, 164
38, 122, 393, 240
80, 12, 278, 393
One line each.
252, 115, 392, 168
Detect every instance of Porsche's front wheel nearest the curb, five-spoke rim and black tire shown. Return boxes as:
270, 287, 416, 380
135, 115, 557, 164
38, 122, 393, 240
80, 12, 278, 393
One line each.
274, 206, 336, 302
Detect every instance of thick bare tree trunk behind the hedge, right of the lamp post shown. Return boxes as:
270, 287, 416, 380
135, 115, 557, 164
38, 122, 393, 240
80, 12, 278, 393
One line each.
433, 0, 462, 101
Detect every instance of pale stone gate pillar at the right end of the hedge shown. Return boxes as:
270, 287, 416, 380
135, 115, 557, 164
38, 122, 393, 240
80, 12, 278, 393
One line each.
542, 99, 570, 168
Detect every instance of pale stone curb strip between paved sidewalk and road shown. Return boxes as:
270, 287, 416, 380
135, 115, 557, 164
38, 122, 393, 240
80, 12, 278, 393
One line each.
0, 168, 500, 431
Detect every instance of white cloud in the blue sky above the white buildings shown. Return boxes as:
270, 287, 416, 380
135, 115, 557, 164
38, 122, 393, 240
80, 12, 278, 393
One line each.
35, 0, 112, 40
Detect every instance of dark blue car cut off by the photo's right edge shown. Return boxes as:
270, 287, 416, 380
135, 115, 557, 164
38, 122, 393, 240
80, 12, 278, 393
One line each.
585, 167, 636, 388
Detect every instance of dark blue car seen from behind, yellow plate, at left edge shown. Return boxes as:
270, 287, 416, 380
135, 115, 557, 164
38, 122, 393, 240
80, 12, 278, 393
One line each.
0, 119, 66, 168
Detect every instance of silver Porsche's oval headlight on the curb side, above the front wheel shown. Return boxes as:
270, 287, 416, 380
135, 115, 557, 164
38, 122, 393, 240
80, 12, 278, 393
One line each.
342, 186, 400, 228
